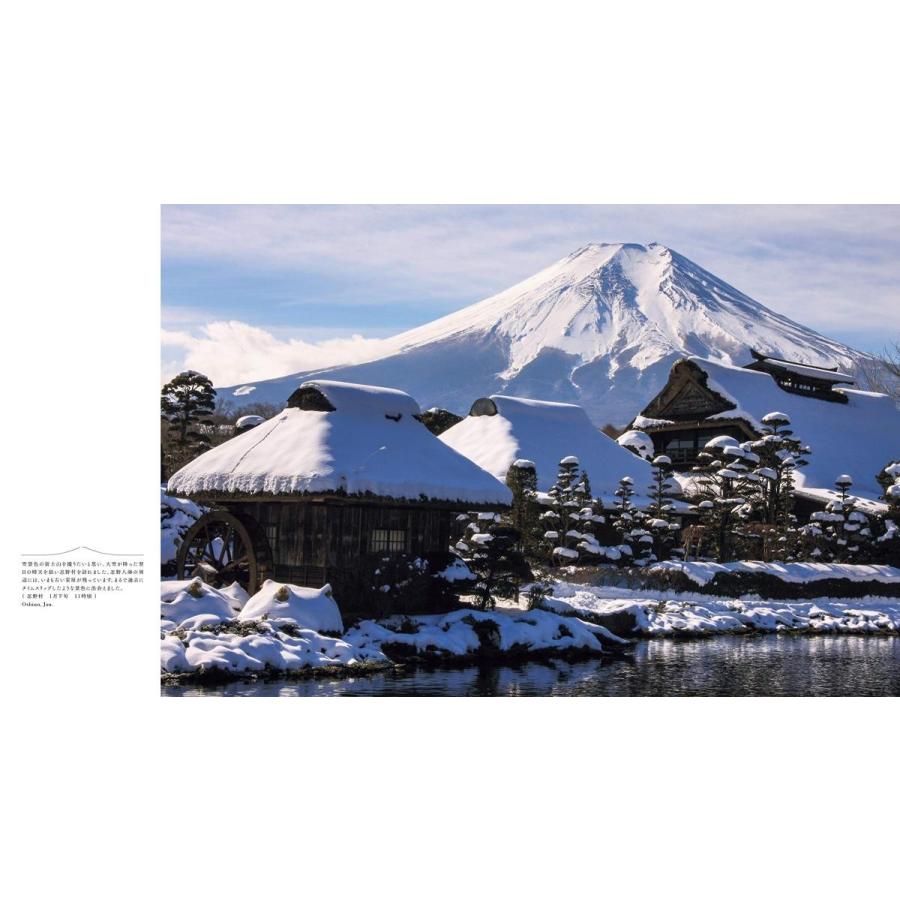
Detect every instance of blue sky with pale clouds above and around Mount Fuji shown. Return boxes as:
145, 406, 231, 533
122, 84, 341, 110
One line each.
162, 205, 900, 385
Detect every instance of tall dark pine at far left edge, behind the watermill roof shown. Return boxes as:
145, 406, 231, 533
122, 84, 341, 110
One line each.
160, 371, 216, 471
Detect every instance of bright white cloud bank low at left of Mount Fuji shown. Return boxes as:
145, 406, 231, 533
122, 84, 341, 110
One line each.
161, 320, 386, 386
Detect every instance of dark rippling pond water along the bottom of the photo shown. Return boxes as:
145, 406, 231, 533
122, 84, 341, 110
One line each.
162, 635, 900, 697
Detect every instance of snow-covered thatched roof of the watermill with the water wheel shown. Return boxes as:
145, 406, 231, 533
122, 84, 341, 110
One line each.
169, 380, 510, 504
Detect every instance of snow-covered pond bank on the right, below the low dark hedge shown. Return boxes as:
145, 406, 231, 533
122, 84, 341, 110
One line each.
544, 581, 900, 637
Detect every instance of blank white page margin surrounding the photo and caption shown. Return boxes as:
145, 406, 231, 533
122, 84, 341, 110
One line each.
0, 2, 900, 897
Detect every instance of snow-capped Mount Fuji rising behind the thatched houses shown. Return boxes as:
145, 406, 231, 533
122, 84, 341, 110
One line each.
219, 243, 870, 425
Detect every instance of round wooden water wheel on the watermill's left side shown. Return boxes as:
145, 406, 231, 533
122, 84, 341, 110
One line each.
177, 509, 272, 595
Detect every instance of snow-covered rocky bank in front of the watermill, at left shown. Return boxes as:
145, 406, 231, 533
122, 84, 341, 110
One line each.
160, 579, 626, 676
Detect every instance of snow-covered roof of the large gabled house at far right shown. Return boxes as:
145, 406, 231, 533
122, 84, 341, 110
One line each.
688, 356, 900, 499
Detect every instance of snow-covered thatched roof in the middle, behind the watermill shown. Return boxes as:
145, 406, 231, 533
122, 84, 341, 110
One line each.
440, 395, 650, 503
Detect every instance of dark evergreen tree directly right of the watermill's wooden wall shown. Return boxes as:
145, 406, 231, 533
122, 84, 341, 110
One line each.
456, 513, 533, 609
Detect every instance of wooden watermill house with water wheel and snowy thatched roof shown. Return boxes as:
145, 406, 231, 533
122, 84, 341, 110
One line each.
169, 380, 511, 608
